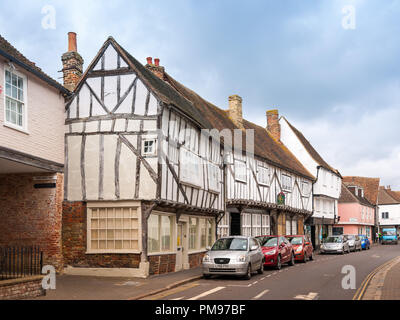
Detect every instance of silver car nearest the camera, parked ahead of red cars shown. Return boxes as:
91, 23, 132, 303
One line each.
203, 236, 264, 279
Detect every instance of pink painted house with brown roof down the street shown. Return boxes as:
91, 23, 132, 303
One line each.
333, 183, 375, 241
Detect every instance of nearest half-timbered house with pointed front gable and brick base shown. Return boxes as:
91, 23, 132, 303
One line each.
63, 37, 224, 276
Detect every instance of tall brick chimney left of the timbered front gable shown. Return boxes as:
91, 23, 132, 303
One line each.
61, 32, 83, 91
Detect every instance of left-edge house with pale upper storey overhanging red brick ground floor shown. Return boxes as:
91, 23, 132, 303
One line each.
0, 36, 69, 278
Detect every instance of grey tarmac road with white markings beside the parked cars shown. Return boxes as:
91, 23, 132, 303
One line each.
144, 245, 400, 300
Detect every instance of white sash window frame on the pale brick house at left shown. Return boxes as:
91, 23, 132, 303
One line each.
3, 67, 29, 134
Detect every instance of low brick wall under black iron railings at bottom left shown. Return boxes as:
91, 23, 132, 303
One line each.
0, 276, 46, 300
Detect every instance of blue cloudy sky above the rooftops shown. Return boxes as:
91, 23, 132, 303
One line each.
0, 0, 400, 189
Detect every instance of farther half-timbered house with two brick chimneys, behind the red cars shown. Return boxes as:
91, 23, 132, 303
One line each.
159, 73, 315, 240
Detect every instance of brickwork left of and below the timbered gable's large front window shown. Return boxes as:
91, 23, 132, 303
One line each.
62, 201, 140, 268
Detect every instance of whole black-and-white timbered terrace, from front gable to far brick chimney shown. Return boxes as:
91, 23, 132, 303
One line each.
63, 34, 315, 276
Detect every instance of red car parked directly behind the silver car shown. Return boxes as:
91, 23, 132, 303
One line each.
256, 236, 295, 270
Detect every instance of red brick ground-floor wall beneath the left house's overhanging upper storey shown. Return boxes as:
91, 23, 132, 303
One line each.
0, 173, 63, 271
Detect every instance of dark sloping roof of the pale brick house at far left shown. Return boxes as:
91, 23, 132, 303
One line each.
0, 35, 70, 95
